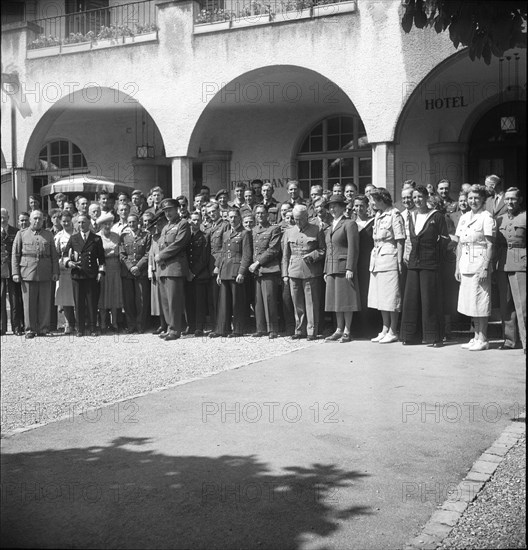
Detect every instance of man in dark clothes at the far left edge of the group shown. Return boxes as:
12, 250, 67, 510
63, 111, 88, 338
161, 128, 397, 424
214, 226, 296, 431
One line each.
0, 208, 24, 336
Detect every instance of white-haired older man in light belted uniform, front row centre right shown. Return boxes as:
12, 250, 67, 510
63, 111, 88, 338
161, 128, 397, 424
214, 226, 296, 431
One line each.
282, 205, 326, 340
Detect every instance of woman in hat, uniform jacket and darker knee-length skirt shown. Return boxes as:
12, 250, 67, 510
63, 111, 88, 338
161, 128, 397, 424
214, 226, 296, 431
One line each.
324, 194, 361, 343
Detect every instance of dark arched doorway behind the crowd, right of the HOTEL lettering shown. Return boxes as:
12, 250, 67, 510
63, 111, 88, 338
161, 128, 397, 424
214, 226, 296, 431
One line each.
468, 101, 526, 187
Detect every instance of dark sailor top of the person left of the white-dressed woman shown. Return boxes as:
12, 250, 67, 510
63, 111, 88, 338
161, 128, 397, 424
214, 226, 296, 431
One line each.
407, 210, 451, 270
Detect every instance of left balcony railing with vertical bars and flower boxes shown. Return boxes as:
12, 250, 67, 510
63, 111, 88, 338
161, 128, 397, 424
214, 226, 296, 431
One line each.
28, 1, 158, 50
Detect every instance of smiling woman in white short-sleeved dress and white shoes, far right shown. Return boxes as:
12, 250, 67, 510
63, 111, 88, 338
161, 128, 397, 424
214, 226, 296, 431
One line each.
455, 185, 496, 351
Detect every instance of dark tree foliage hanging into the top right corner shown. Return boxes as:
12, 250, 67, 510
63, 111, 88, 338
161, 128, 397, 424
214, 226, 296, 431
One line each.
401, 0, 528, 65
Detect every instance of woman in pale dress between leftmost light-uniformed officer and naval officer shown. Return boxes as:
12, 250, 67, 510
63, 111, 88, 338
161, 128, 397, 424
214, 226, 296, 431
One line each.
54, 210, 75, 334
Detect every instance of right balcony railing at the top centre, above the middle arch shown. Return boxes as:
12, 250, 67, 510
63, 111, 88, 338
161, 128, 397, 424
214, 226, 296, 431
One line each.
194, 0, 356, 28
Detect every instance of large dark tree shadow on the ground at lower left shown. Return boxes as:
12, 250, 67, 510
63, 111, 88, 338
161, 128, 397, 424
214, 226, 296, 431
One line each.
1, 437, 371, 549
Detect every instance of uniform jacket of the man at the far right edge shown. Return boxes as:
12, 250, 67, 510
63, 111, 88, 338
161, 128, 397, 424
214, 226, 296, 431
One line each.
496, 211, 526, 271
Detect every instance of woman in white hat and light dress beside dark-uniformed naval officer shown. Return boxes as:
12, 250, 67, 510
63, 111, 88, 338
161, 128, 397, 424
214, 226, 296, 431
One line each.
97, 212, 123, 333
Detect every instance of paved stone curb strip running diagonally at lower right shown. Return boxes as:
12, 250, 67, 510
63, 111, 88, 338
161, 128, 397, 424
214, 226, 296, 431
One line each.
404, 413, 526, 550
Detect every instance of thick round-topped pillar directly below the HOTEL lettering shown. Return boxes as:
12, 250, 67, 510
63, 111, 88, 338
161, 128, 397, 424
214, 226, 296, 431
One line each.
425, 141, 467, 197
